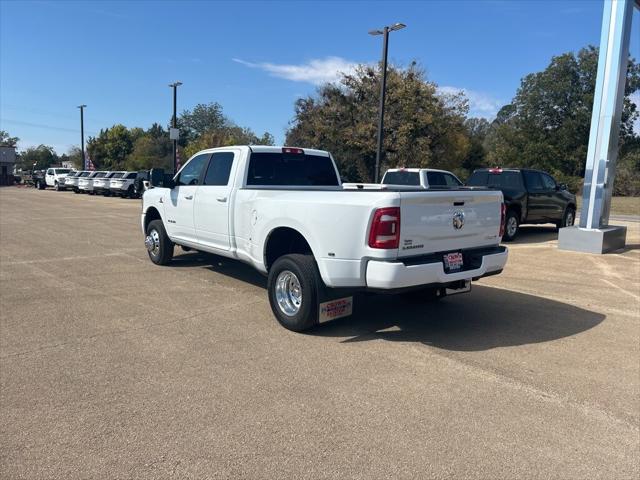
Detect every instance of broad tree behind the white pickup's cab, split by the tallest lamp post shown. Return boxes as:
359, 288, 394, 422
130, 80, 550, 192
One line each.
286, 62, 469, 181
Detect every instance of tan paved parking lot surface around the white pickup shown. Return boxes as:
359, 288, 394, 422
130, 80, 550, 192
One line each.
0, 187, 640, 479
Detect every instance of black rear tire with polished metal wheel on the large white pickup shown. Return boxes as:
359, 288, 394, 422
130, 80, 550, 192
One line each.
267, 253, 322, 332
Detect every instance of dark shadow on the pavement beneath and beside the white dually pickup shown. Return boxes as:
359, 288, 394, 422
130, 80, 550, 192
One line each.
171, 253, 606, 351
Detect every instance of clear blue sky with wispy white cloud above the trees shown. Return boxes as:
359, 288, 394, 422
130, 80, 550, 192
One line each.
0, 0, 640, 153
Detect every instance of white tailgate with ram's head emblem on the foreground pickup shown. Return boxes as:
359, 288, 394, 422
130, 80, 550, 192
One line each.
398, 190, 502, 257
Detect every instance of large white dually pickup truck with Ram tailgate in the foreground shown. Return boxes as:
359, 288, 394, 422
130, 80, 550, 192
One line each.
141, 146, 508, 331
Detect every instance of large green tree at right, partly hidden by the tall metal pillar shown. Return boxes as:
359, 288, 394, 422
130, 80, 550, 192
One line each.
485, 46, 640, 190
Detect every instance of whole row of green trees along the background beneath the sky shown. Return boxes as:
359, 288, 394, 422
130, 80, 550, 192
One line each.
5, 46, 640, 195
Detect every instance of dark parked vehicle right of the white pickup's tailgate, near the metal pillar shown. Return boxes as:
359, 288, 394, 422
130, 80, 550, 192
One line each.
467, 168, 576, 241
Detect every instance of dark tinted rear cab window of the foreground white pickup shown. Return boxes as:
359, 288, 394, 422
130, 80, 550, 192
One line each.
247, 152, 339, 187
